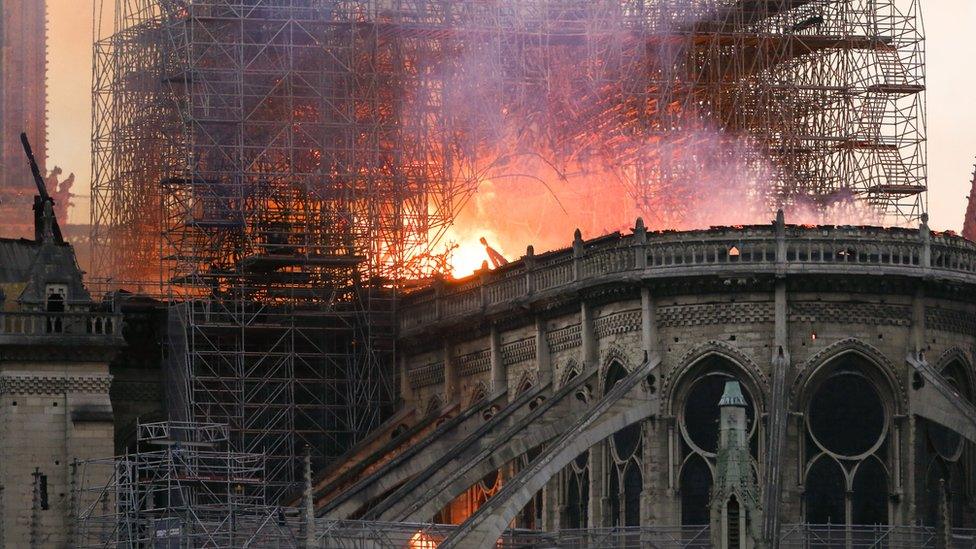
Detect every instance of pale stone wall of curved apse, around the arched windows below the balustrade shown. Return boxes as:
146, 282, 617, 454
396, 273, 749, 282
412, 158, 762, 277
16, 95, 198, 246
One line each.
396, 277, 976, 528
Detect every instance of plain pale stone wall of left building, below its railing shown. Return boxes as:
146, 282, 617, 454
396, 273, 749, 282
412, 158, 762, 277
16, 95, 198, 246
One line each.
0, 362, 114, 547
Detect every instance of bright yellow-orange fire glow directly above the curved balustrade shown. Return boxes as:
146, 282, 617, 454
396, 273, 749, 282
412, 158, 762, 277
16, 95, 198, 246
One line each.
441, 132, 881, 278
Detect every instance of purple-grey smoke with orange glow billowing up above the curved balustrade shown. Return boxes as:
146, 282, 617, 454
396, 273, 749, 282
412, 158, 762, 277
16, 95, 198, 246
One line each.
400, 0, 880, 275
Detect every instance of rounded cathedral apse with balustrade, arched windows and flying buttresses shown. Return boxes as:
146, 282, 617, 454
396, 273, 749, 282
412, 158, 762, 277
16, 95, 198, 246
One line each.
313, 214, 976, 547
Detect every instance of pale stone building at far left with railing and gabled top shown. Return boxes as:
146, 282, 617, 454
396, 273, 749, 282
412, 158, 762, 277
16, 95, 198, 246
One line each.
0, 204, 123, 547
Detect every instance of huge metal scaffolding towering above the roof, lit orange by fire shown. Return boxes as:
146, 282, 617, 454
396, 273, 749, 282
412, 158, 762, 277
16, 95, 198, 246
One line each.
92, 0, 926, 498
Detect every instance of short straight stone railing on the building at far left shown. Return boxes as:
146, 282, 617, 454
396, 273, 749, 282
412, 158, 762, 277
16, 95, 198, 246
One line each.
0, 311, 122, 341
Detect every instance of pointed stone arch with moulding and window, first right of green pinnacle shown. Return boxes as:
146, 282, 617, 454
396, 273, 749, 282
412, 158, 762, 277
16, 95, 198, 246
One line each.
791, 338, 896, 525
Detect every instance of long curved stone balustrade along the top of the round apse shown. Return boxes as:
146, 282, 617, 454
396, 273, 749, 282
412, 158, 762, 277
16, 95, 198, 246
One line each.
400, 218, 976, 331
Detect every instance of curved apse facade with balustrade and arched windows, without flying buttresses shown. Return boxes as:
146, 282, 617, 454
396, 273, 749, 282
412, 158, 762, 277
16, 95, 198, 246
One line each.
376, 216, 976, 535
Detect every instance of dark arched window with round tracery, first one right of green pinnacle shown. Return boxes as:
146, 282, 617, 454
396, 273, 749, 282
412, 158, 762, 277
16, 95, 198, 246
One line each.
803, 353, 892, 525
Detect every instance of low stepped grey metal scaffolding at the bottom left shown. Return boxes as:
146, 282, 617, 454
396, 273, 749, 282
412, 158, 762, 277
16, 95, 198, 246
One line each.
70, 423, 304, 548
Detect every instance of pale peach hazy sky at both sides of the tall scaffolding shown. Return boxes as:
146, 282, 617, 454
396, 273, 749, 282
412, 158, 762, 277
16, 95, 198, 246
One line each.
49, 0, 976, 231
